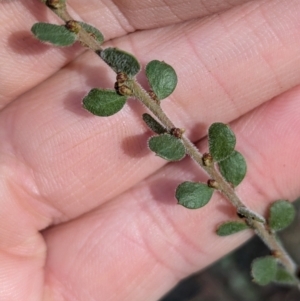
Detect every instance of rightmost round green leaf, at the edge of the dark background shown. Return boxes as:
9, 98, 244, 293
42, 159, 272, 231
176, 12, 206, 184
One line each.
268, 200, 296, 231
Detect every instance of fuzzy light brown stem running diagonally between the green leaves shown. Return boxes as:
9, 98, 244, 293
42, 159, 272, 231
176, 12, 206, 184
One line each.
42, 0, 300, 289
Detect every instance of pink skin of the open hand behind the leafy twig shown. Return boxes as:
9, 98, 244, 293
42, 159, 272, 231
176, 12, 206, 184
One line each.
0, 0, 300, 301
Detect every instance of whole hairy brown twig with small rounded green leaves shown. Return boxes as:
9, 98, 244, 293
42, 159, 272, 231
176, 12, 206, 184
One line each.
32, 0, 300, 287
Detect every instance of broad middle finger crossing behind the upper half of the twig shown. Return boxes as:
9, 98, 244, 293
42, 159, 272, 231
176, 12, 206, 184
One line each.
0, 1, 300, 222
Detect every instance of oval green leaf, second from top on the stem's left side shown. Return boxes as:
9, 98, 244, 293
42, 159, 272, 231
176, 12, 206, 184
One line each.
83, 89, 127, 116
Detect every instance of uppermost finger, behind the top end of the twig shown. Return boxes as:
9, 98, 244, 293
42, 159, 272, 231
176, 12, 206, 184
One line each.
0, 0, 251, 108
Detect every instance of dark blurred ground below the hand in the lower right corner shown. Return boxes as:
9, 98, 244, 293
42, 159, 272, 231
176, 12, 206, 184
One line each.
159, 198, 300, 301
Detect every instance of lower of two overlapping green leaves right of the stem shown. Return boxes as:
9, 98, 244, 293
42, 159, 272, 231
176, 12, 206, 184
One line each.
218, 150, 247, 186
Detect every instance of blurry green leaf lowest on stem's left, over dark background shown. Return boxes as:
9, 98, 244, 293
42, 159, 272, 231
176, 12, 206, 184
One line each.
251, 256, 277, 285
